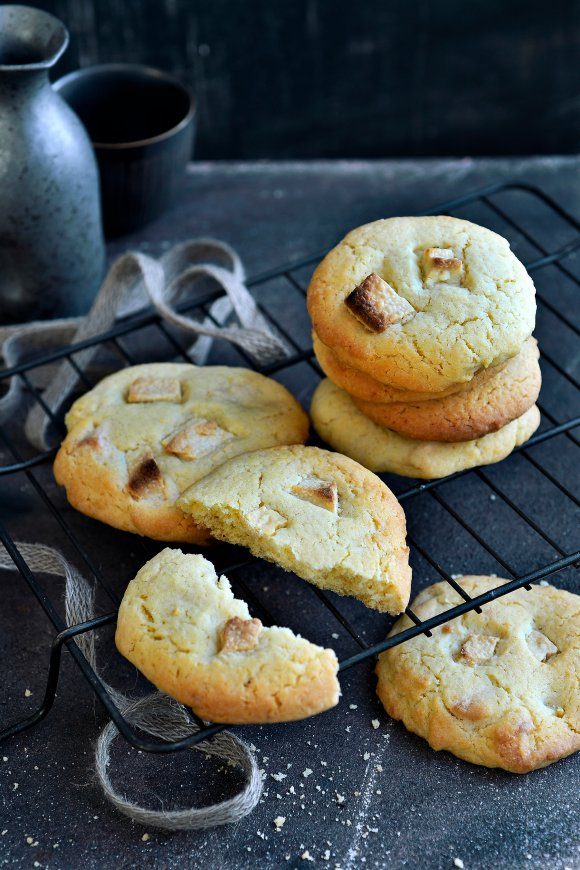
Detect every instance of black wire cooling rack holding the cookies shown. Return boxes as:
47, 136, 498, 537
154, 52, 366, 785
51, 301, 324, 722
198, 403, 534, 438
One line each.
0, 184, 580, 753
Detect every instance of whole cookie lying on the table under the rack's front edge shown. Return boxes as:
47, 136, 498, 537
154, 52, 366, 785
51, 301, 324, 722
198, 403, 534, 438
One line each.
377, 576, 580, 773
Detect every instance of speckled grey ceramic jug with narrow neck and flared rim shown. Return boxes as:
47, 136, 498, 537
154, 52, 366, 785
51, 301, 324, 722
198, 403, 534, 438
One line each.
0, 5, 105, 323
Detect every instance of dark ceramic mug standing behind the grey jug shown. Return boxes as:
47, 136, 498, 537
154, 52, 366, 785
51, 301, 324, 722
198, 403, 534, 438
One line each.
54, 63, 195, 236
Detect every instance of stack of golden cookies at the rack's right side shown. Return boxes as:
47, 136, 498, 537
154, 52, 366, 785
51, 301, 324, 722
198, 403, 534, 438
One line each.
308, 216, 541, 478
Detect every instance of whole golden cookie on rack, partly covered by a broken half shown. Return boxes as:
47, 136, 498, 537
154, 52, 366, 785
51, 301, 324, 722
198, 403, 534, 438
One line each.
54, 363, 308, 543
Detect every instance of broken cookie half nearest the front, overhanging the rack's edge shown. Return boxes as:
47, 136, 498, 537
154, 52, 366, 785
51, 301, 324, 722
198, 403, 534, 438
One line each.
115, 548, 340, 723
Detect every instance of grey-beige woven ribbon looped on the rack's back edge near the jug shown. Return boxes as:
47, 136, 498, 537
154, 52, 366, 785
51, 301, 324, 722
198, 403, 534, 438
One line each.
0, 239, 287, 450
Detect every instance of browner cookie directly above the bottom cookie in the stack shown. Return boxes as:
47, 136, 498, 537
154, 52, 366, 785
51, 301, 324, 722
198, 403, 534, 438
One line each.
353, 338, 542, 441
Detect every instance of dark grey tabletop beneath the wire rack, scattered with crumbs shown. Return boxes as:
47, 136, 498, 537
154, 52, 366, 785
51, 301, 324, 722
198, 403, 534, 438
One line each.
0, 157, 580, 870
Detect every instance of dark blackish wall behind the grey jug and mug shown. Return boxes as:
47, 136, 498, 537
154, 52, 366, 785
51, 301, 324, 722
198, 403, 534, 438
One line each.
28, 0, 580, 158
